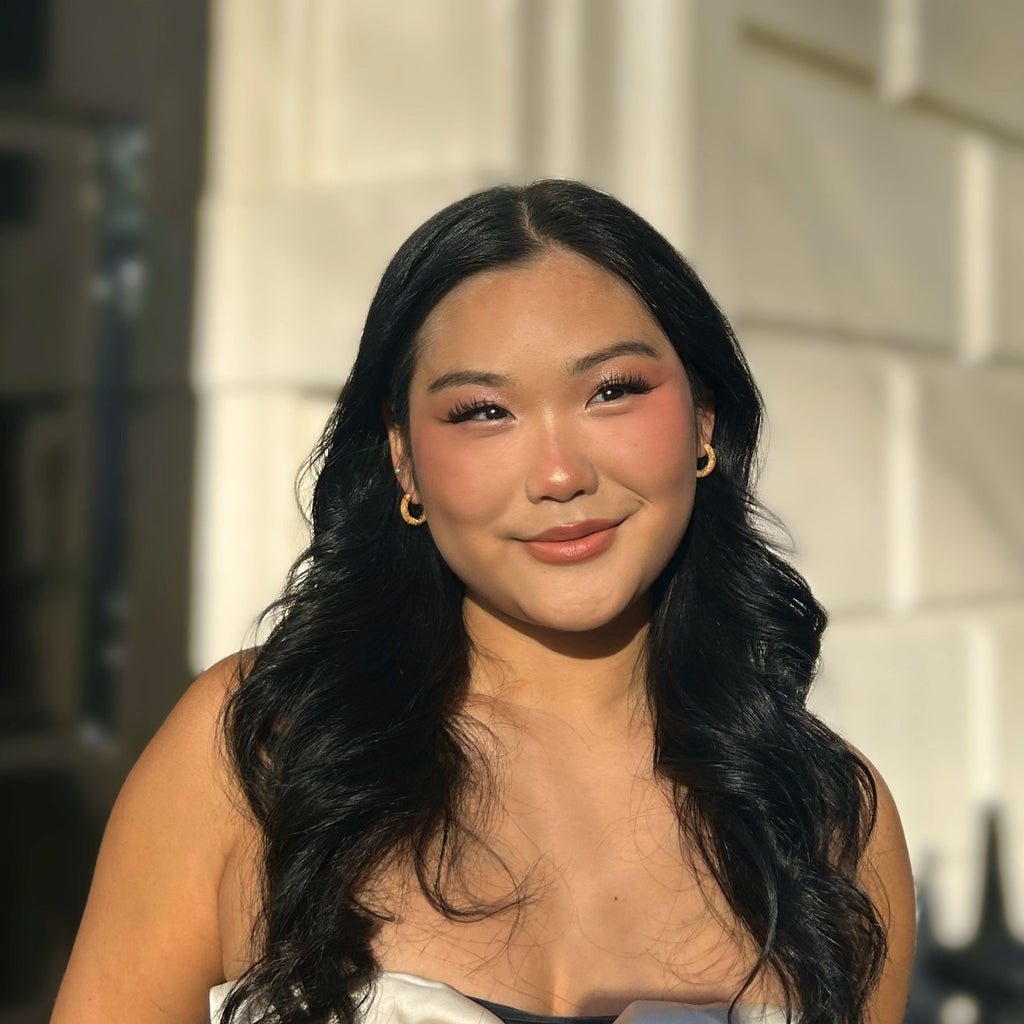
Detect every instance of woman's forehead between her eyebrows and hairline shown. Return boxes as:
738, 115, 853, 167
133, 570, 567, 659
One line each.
417, 250, 674, 375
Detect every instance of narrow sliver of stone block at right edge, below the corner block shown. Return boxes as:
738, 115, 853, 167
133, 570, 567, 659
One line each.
993, 146, 1024, 359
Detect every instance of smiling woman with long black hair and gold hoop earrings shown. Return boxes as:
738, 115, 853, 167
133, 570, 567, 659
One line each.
53, 181, 913, 1024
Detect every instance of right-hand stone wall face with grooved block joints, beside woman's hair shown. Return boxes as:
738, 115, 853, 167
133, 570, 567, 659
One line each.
731, 0, 1024, 940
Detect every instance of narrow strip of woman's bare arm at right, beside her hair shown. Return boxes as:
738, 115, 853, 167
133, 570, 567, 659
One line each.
854, 750, 916, 1024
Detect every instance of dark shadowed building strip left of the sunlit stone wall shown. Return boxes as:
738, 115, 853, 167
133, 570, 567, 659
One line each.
0, 0, 210, 1024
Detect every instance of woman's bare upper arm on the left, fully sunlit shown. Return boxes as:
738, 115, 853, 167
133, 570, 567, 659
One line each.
51, 655, 256, 1024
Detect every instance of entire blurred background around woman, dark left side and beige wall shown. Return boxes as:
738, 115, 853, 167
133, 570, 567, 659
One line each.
0, 0, 1024, 1024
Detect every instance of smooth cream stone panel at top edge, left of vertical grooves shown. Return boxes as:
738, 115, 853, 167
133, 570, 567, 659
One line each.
301, 0, 516, 184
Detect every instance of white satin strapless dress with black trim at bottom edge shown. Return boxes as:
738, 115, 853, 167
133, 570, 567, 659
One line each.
210, 971, 782, 1024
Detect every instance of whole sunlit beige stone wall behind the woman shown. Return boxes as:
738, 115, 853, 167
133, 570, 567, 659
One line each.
193, 0, 1024, 937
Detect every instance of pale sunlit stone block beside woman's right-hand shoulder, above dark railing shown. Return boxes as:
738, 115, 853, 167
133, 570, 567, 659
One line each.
811, 617, 977, 936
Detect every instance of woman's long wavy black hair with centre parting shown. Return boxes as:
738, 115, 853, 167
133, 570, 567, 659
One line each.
224, 180, 886, 1024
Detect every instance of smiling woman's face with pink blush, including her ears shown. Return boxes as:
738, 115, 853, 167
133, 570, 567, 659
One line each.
389, 250, 712, 632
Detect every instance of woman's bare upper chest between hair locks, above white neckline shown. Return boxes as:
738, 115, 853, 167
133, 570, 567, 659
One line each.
364, 781, 770, 1014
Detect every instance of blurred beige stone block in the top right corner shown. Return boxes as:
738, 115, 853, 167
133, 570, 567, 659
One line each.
916, 0, 1024, 133
